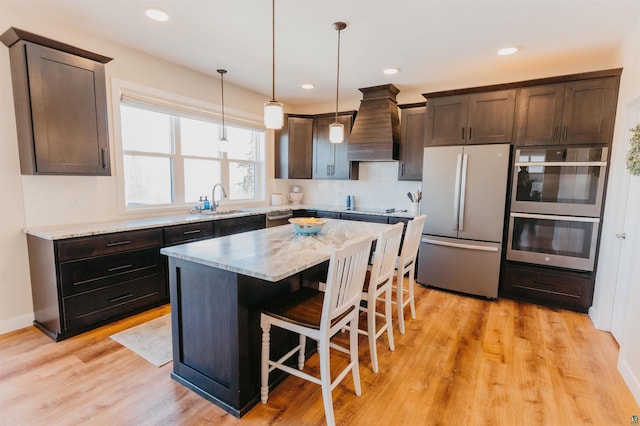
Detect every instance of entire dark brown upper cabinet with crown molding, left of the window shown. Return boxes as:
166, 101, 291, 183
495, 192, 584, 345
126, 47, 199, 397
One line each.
0, 28, 111, 176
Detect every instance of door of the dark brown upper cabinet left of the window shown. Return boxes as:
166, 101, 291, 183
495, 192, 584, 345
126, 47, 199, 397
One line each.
21, 43, 111, 175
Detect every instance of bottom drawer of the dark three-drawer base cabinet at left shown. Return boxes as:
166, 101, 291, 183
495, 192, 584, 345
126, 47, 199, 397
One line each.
63, 274, 168, 330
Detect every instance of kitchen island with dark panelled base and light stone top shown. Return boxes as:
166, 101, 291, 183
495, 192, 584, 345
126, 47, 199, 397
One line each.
161, 219, 391, 417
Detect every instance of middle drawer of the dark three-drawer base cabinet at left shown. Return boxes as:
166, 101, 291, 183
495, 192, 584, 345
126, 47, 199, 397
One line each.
60, 248, 165, 296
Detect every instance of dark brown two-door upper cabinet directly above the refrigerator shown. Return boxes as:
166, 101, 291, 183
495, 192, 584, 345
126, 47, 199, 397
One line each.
424, 89, 516, 146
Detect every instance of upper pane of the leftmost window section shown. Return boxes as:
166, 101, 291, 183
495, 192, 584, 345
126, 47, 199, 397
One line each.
121, 105, 173, 154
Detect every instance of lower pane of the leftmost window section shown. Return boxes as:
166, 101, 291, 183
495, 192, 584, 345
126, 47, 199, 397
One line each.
124, 155, 172, 206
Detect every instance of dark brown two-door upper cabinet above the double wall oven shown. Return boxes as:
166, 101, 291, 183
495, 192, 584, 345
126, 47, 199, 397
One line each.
515, 77, 619, 145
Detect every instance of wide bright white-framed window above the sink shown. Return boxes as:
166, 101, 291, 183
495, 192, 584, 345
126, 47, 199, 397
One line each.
120, 91, 265, 209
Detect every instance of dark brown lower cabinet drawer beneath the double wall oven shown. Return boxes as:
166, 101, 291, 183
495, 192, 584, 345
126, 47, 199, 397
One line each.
499, 262, 594, 313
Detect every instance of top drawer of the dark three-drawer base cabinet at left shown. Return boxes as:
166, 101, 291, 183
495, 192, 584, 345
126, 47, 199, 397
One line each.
57, 229, 162, 262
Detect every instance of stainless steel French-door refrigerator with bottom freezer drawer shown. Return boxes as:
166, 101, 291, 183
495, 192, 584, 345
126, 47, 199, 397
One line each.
417, 144, 510, 299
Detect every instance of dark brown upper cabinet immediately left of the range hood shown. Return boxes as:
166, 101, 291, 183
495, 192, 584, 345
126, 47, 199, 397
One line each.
313, 111, 360, 180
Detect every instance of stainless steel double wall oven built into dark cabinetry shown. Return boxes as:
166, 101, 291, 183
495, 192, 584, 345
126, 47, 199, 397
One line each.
506, 147, 607, 271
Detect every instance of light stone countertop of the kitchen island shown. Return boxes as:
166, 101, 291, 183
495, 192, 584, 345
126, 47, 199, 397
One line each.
160, 219, 392, 282
